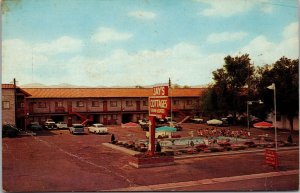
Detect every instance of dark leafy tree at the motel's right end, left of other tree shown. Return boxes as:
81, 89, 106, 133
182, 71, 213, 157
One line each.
211, 54, 254, 118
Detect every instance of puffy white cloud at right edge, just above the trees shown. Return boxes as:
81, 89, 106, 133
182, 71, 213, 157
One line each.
240, 23, 299, 65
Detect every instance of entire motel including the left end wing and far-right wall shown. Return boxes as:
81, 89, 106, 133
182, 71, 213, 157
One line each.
2, 84, 299, 130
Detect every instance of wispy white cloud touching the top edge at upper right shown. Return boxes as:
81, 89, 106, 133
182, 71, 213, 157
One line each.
198, 0, 272, 17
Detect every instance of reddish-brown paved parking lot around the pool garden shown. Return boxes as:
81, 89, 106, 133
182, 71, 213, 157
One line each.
2, 124, 299, 192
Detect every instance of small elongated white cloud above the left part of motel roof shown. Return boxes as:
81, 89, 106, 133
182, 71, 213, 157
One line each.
34, 36, 83, 55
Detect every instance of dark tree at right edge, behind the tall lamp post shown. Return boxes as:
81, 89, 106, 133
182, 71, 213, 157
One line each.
258, 57, 299, 132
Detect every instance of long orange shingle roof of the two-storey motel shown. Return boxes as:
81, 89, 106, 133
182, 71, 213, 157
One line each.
24, 88, 205, 98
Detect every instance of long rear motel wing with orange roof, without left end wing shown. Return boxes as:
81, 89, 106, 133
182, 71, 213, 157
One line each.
19, 88, 204, 125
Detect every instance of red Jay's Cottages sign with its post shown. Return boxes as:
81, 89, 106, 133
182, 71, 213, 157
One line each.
148, 86, 170, 156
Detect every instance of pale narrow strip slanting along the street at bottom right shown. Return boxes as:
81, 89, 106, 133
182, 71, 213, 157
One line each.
105, 170, 299, 191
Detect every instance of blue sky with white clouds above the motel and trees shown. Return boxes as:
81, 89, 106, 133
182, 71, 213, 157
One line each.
2, 0, 299, 87
